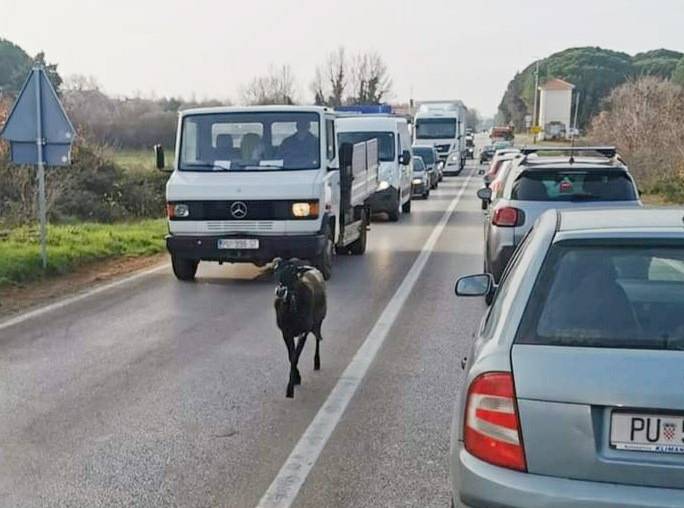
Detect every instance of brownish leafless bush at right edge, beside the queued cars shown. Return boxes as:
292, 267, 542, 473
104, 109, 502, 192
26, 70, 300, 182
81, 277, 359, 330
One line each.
589, 76, 684, 198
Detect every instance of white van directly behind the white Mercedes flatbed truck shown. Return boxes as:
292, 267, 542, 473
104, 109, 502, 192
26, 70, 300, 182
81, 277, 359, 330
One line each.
336, 113, 413, 222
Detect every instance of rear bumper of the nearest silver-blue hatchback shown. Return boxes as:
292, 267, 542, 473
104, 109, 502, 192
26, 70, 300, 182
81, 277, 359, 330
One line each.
451, 443, 684, 508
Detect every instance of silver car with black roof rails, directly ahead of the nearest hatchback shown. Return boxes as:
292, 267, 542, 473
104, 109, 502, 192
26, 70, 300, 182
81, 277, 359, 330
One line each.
477, 147, 641, 281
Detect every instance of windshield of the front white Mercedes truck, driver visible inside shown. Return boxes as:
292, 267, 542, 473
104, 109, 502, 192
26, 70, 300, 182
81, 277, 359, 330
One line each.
178, 112, 321, 171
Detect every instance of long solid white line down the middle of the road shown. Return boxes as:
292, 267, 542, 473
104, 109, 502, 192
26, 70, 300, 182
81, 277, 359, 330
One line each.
257, 171, 473, 508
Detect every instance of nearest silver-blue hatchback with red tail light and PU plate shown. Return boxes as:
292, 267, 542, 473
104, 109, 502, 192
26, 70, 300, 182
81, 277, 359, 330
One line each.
450, 208, 684, 508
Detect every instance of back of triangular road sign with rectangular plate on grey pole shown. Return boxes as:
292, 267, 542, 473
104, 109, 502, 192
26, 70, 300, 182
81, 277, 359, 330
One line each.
0, 68, 75, 166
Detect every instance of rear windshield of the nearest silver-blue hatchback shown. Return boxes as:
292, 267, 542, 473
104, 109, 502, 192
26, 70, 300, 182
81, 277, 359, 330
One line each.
516, 240, 684, 350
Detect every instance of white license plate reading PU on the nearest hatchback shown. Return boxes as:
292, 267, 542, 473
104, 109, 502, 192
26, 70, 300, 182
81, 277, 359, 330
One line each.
610, 412, 684, 453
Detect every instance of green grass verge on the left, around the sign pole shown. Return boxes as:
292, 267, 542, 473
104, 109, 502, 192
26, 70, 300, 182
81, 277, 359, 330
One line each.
0, 219, 167, 287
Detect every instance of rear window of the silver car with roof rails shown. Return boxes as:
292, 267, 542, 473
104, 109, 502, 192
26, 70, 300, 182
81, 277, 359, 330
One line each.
511, 170, 637, 201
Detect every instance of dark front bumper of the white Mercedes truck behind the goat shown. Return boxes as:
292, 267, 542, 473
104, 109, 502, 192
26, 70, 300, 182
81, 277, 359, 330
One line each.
166, 232, 326, 264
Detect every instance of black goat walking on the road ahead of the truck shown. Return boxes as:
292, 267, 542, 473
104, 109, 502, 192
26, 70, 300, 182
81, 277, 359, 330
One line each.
273, 258, 327, 398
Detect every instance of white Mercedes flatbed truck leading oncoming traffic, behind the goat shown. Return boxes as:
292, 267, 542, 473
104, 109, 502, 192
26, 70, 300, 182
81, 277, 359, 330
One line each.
155, 106, 378, 280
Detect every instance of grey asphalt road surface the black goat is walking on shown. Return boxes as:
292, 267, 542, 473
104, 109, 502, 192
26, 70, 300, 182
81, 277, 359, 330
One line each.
0, 160, 484, 507
